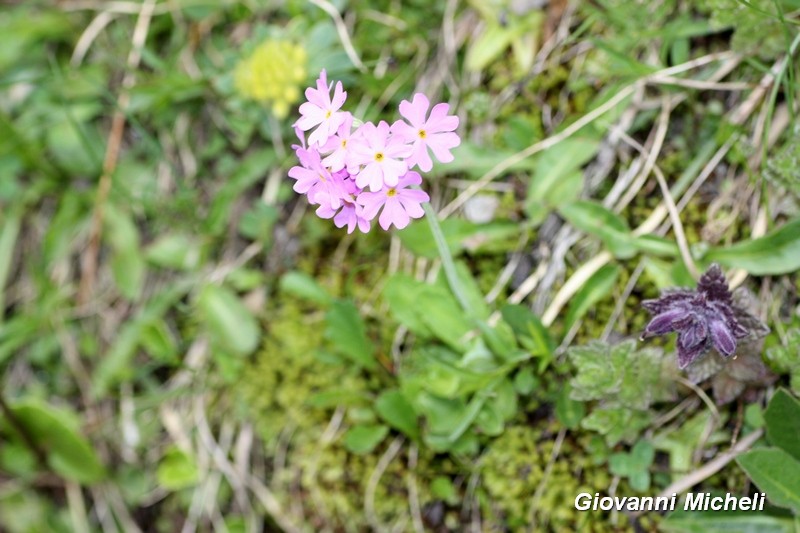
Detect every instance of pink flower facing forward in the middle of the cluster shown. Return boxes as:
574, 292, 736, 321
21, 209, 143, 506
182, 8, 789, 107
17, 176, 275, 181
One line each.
347, 120, 412, 191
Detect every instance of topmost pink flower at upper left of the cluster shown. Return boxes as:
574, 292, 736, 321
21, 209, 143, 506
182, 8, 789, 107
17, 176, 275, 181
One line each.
295, 69, 347, 146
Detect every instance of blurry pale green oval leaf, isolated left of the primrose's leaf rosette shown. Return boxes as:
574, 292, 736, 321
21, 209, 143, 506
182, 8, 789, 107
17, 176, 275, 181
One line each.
196, 284, 261, 355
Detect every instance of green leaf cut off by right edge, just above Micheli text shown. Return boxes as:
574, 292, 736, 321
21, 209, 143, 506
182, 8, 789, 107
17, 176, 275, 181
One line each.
736, 448, 800, 513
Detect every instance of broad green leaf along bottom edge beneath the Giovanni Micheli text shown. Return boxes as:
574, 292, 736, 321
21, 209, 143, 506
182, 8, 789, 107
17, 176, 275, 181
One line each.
659, 510, 796, 533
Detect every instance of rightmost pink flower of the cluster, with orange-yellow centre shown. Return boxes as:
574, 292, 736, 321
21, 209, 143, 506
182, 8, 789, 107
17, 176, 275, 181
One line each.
392, 93, 461, 172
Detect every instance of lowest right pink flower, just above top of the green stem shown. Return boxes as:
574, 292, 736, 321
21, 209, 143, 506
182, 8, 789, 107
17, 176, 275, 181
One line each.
358, 171, 430, 230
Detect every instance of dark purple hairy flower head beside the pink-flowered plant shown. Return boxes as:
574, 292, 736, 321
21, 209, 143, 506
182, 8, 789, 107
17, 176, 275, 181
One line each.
642, 265, 748, 369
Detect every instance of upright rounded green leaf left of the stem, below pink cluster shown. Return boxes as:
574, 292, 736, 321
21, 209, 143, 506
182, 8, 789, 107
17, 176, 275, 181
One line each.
325, 300, 376, 369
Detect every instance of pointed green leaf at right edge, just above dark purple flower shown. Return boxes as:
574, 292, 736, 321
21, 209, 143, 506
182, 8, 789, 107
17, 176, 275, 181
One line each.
704, 219, 800, 276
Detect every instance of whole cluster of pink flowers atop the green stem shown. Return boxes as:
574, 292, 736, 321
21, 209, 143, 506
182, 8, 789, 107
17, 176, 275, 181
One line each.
289, 70, 461, 233
